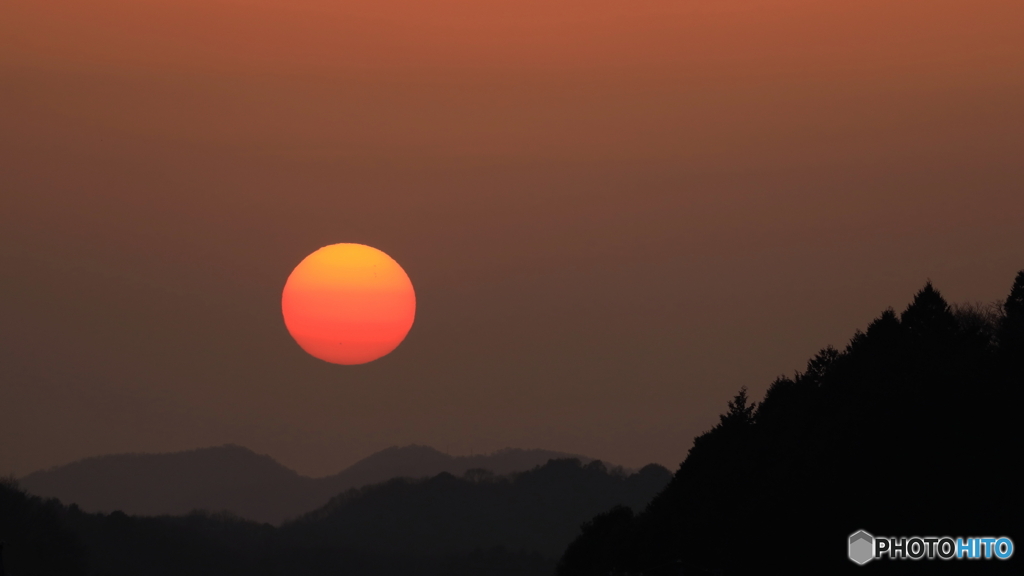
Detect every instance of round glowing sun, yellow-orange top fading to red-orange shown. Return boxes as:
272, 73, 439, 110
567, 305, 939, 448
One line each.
281, 244, 416, 364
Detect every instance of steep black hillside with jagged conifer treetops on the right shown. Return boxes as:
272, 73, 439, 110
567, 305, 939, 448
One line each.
559, 272, 1024, 576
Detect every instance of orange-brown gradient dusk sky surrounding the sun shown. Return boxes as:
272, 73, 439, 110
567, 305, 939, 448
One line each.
0, 0, 1024, 476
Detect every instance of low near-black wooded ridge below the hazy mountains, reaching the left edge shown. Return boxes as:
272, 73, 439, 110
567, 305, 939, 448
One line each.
0, 459, 672, 576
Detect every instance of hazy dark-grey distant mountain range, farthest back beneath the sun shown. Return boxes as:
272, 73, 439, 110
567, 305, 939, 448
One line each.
18, 446, 590, 524
